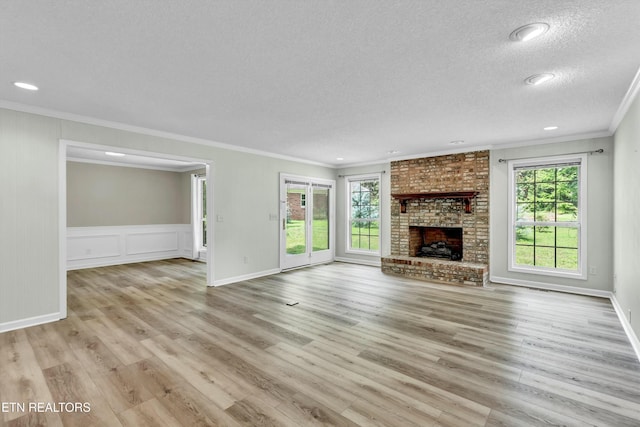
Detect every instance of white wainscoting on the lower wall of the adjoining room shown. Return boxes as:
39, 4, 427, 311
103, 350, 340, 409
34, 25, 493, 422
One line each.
67, 224, 192, 270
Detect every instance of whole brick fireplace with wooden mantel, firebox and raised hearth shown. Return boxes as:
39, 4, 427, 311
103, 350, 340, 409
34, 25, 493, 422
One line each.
382, 151, 489, 286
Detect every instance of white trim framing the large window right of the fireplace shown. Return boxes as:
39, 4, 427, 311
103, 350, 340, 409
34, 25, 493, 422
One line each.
508, 154, 588, 280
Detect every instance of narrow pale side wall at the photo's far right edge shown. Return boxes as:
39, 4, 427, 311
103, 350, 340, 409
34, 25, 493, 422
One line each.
613, 91, 640, 342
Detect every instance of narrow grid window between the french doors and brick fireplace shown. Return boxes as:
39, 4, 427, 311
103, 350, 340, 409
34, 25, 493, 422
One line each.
347, 175, 380, 254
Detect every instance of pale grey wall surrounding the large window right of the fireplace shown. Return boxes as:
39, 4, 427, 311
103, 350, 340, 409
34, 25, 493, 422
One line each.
489, 137, 613, 296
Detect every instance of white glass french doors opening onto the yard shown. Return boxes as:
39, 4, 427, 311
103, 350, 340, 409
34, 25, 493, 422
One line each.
280, 174, 335, 270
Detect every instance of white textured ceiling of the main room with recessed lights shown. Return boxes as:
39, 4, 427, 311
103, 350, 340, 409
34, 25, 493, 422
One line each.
0, 0, 640, 165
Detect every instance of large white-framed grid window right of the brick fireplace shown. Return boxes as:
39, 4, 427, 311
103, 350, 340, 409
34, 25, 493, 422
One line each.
509, 156, 586, 278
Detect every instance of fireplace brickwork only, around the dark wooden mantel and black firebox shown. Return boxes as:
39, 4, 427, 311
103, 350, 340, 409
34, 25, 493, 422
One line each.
383, 151, 489, 284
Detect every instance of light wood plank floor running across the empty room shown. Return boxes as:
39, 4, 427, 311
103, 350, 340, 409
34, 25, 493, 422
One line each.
0, 260, 640, 427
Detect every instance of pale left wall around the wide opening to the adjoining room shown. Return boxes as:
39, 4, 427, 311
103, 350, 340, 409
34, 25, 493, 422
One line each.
0, 109, 335, 331
